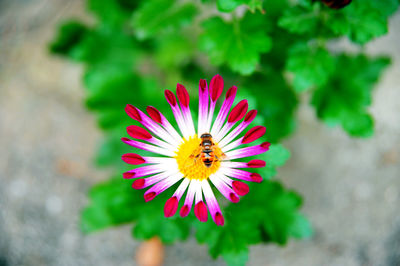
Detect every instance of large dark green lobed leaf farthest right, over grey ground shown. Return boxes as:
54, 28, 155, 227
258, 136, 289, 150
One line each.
311, 54, 389, 137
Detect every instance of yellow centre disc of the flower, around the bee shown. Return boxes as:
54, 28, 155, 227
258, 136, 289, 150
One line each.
175, 135, 223, 180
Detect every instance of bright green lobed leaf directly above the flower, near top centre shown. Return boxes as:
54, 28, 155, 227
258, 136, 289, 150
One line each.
199, 14, 271, 75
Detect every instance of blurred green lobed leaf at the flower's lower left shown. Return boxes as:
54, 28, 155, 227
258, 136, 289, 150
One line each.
81, 177, 192, 243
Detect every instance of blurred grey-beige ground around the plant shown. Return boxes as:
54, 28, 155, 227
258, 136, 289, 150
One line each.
0, 0, 400, 266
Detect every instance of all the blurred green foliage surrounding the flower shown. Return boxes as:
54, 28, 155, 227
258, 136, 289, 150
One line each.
49, 0, 399, 265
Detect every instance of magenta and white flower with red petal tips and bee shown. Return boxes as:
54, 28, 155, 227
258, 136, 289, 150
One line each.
122, 75, 269, 225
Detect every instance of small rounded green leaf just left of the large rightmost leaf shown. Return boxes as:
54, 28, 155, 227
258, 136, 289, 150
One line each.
286, 43, 335, 92
